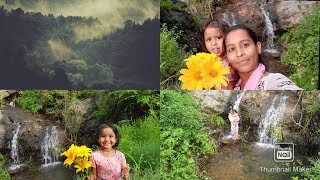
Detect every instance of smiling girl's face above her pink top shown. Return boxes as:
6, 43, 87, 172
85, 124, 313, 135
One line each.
98, 128, 118, 149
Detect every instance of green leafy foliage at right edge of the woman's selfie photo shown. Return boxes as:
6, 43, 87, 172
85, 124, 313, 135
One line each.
280, 6, 320, 90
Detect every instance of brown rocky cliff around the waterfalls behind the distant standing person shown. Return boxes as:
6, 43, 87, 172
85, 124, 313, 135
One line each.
190, 91, 320, 153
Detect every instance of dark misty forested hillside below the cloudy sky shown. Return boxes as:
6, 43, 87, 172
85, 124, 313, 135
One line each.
0, 5, 160, 89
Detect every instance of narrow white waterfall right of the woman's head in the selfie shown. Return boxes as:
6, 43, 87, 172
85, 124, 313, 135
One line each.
260, 1, 278, 52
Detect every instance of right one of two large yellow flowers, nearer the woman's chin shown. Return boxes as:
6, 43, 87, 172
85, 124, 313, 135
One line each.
201, 59, 230, 90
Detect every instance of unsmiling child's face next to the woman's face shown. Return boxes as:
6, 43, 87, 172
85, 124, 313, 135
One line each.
204, 27, 224, 57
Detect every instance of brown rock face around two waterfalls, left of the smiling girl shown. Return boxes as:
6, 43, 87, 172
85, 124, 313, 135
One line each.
0, 106, 68, 163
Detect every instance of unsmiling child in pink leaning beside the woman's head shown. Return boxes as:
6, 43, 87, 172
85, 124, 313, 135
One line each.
202, 20, 239, 90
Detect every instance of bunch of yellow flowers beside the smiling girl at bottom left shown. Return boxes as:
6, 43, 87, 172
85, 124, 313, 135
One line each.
61, 144, 92, 179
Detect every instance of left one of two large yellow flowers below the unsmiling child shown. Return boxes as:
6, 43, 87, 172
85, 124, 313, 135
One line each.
179, 56, 206, 90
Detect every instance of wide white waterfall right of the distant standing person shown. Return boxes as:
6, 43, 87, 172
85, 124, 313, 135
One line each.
257, 95, 288, 147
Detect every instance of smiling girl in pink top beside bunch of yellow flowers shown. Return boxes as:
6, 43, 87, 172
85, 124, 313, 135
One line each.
88, 124, 129, 180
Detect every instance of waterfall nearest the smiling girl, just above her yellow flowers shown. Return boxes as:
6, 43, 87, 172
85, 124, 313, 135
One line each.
41, 126, 60, 167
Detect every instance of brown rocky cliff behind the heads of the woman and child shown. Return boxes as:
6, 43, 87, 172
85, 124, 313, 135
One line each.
165, 0, 320, 50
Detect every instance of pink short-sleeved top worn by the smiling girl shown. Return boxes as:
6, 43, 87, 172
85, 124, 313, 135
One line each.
90, 150, 127, 180
